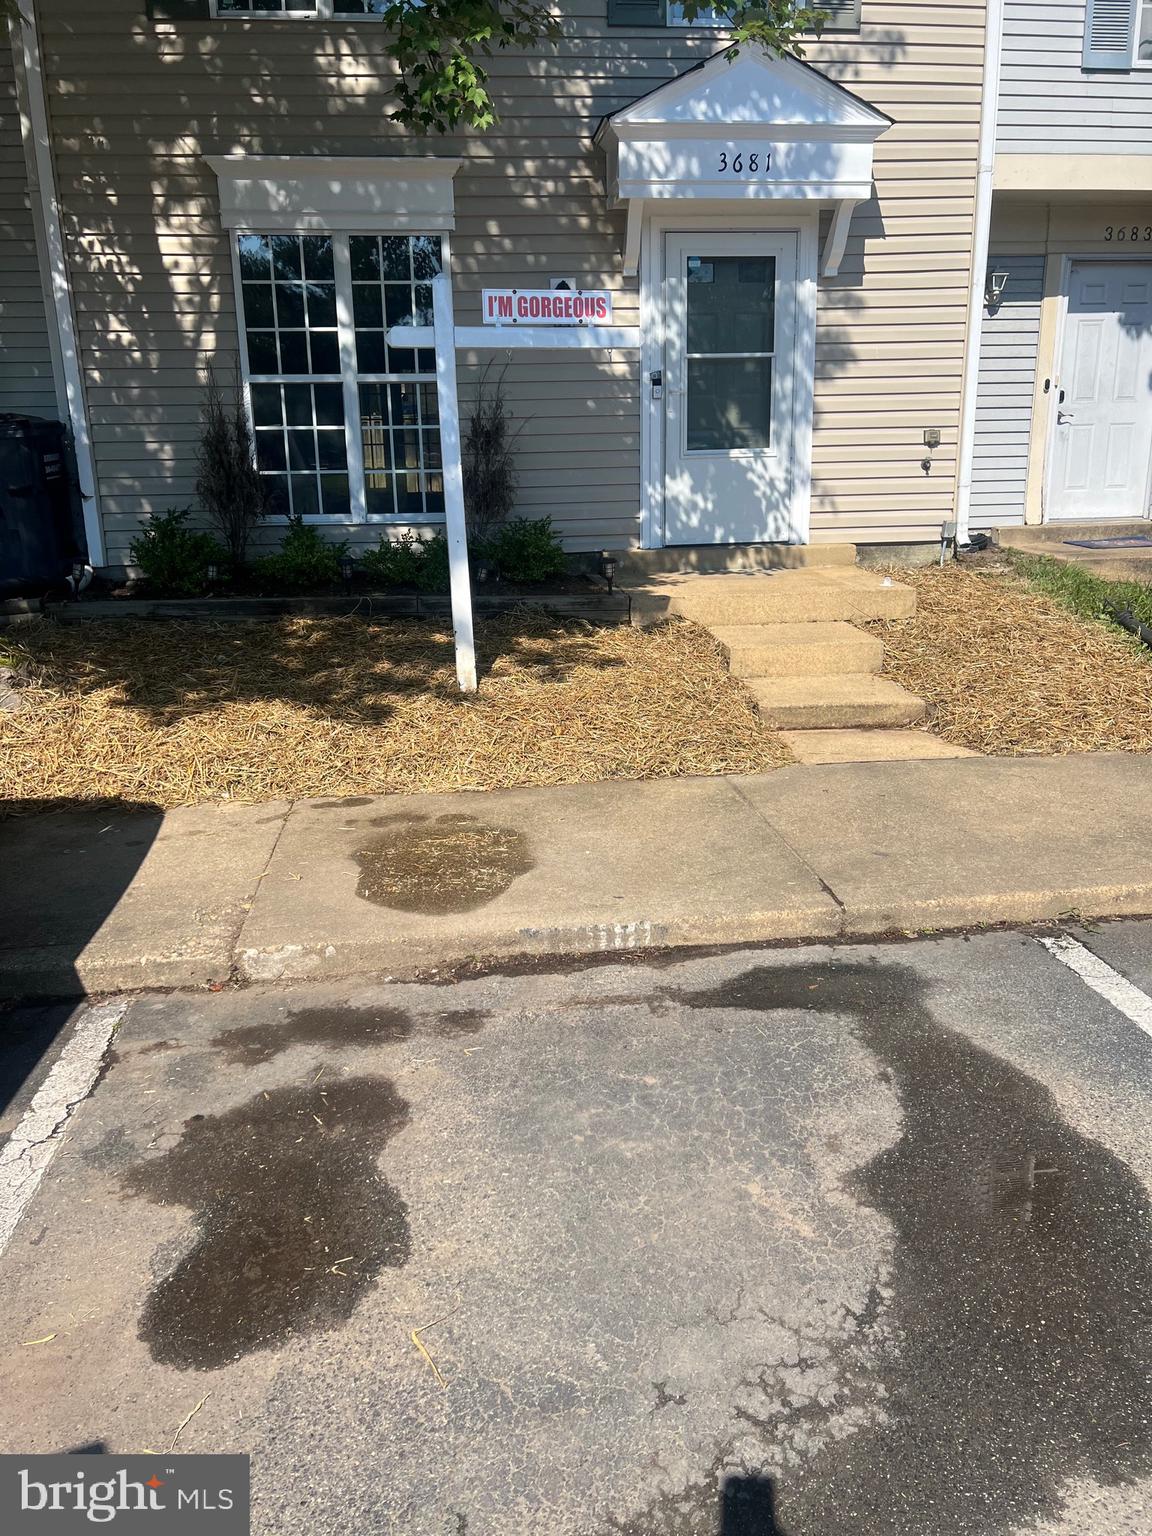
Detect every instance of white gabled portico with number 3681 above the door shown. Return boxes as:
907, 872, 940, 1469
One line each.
596, 45, 892, 272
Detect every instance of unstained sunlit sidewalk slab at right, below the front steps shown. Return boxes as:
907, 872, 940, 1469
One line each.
734, 753, 1152, 935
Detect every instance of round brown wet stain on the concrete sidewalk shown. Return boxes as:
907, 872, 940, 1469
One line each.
355, 816, 535, 917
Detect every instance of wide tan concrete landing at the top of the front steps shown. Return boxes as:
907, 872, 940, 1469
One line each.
627, 565, 915, 628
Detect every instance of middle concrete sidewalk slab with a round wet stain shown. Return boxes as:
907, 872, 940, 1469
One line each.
238, 779, 839, 982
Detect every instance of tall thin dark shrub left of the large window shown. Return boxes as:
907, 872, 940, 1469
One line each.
197, 362, 269, 570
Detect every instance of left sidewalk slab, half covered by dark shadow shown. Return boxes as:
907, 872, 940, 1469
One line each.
0, 802, 289, 997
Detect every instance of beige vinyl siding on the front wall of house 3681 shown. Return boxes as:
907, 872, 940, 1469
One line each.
41, 0, 983, 561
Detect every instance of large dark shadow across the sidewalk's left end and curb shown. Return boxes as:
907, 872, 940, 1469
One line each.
0, 799, 163, 1144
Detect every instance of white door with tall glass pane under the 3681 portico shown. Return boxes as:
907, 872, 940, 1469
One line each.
664, 233, 811, 544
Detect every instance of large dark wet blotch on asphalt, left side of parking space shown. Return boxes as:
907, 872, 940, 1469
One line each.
124, 1077, 409, 1370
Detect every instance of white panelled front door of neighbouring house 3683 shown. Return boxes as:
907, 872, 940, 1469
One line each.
1048, 261, 1152, 518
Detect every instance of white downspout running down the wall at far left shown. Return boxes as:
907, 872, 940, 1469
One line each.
11, 0, 104, 565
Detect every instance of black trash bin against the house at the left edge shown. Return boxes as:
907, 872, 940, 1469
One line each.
0, 415, 84, 598
